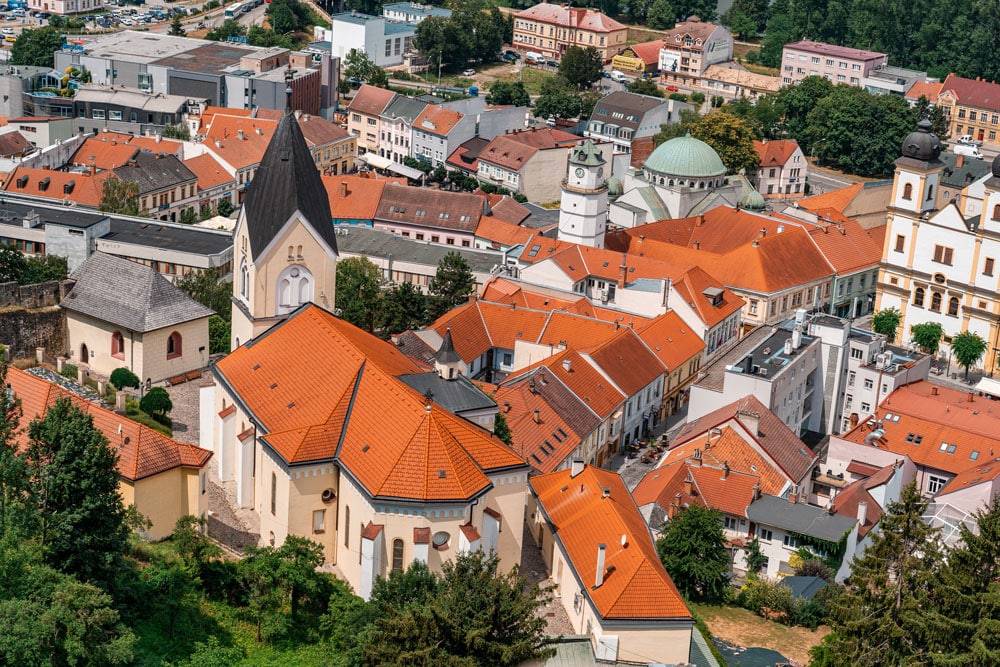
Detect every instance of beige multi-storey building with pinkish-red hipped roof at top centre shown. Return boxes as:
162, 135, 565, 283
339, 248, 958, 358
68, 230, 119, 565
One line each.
513, 2, 628, 63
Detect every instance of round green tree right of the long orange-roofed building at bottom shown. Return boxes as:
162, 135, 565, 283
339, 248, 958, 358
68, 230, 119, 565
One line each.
656, 503, 729, 602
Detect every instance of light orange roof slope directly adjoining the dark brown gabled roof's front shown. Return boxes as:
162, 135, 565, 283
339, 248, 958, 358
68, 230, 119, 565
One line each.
659, 426, 798, 496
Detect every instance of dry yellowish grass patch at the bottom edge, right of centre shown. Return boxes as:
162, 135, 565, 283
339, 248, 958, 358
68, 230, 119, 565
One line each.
691, 604, 830, 664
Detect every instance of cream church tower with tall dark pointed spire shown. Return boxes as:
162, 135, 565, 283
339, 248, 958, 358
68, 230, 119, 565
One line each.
230, 70, 338, 349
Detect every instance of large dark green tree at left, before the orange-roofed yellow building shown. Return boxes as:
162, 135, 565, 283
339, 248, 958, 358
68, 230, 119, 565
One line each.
24, 398, 128, 587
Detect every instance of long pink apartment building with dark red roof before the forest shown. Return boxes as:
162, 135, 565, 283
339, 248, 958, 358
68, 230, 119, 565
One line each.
781, 39, 889, 86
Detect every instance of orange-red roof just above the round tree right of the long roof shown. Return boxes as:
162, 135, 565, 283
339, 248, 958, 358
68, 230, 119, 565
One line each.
632, 459, 760, 517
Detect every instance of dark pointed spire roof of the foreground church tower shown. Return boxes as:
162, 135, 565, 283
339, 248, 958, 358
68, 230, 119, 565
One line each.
243, 104, 337, 256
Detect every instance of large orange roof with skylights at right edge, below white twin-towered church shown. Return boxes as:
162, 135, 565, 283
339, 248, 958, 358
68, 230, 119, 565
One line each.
840, 380, 1000, 475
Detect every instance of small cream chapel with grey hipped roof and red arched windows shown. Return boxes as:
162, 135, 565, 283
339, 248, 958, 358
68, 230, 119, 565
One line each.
60, 252, 213, 385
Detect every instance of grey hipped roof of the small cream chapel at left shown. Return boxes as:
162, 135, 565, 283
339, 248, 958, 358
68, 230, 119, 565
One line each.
59, 252, 212, 333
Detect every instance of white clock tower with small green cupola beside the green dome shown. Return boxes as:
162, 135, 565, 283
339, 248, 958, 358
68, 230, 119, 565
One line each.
559, 140, 609, 248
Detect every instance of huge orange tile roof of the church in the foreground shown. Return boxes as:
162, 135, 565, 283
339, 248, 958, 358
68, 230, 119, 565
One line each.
215, 305, 524, 500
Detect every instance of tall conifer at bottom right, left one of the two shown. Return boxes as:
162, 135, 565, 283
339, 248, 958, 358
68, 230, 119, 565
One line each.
813, 483, 942, 665
